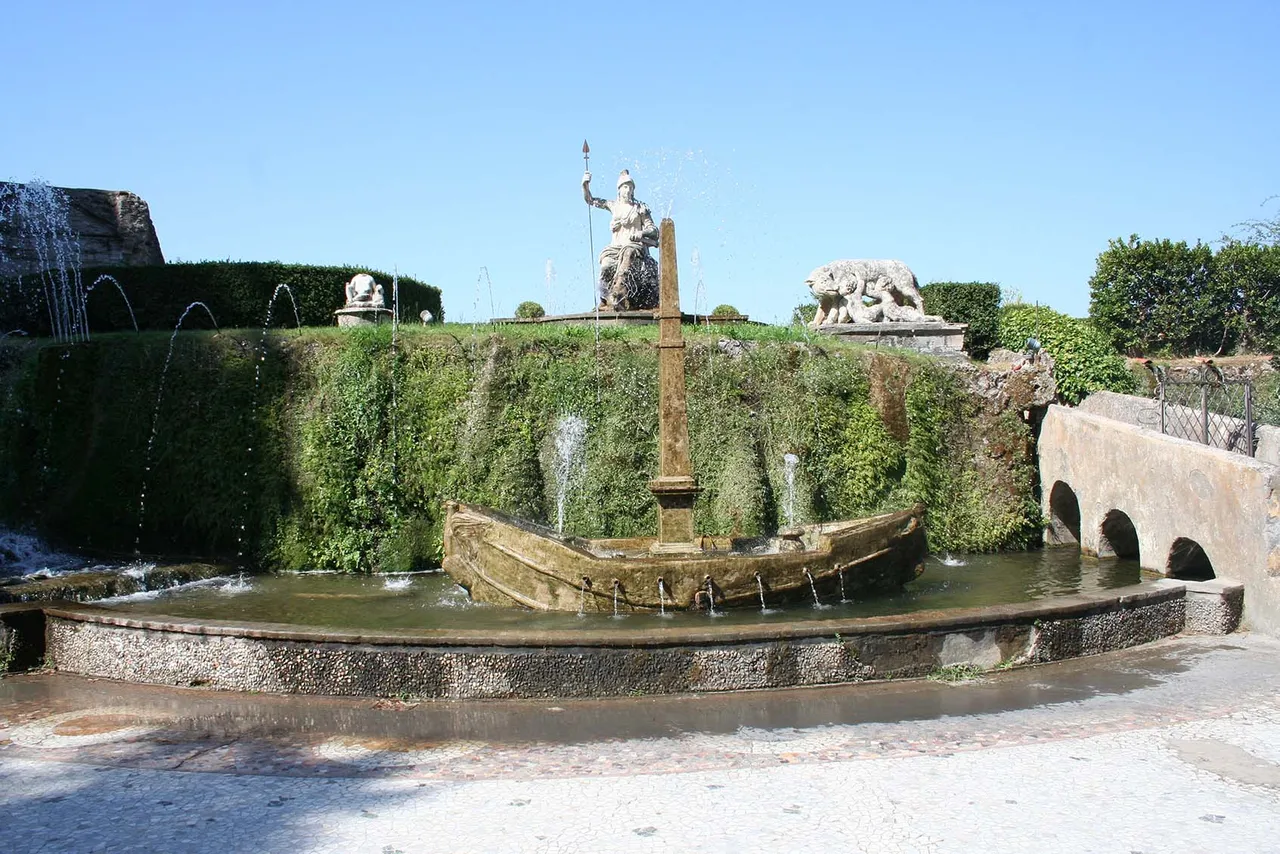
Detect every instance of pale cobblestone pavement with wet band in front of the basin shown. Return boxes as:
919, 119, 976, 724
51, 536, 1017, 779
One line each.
0, 635, 1280, 854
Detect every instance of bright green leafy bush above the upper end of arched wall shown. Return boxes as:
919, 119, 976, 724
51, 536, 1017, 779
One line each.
1000, 303, 1134, 403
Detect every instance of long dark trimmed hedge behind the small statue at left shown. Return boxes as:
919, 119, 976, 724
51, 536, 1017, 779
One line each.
0, 261, 444, 335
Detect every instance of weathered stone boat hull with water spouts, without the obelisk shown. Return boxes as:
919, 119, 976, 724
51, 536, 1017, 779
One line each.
444, 502, 927, 613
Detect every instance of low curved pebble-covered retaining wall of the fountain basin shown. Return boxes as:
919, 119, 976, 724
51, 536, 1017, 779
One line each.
46, 584, 1184, 699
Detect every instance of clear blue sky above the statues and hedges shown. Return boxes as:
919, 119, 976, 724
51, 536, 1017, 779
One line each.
0, 0, 1280, 320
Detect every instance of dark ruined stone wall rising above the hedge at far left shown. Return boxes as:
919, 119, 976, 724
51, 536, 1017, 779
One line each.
0, 182, 164, 277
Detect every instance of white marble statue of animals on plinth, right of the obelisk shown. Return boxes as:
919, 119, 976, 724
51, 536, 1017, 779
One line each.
805, 260, 942, 326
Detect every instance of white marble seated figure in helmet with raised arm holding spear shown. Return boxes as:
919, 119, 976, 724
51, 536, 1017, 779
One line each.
582, 169, 658, 311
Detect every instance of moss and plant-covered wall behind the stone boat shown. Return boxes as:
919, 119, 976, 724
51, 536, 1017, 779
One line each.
0, 325, 1038, 571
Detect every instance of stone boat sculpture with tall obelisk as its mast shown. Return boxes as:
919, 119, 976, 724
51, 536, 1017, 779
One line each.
444, 219, 927, 612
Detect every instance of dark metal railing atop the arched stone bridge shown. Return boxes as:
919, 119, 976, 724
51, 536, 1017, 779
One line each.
1151, 365, 1257, 457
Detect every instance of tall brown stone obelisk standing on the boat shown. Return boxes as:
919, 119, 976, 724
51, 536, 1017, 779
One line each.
649, 219, 699, 554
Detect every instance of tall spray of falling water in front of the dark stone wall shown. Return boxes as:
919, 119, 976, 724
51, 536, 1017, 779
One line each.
0, 181, 88, 342
